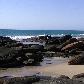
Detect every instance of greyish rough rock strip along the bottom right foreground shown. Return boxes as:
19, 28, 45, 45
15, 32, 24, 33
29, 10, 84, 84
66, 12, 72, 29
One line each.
33, 77, 84, 84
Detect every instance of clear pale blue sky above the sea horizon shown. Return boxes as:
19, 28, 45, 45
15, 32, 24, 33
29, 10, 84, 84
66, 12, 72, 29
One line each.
0, 0, 84, 30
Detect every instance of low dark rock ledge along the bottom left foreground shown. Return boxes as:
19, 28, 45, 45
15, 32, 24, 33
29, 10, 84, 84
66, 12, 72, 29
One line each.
0, 76, 40, 84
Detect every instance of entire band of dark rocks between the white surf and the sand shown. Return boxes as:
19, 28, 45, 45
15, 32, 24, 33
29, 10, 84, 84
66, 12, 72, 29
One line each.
0, 35, 84, 67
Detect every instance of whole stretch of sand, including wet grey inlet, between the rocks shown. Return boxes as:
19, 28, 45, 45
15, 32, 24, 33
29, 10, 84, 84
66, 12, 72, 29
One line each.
0, 57, 84, 78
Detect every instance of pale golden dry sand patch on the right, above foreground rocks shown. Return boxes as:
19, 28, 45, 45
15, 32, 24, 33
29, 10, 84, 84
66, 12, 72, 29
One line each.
40, 63, 84, 78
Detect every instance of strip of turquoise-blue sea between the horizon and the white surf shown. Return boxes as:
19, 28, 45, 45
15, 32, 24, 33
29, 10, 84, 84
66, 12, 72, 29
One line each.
0, 29, 84, 36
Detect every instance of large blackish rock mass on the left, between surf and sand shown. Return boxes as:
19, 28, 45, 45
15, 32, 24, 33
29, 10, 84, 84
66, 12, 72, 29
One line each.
0, 36, 44, 67
